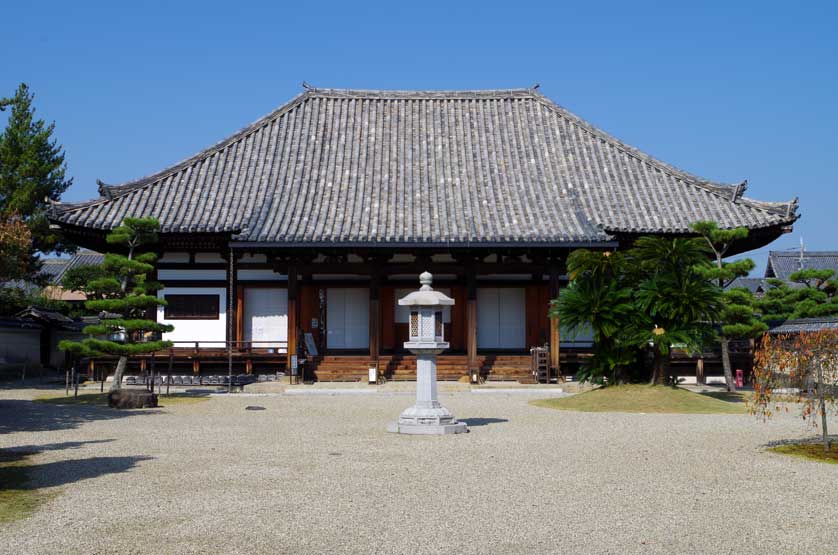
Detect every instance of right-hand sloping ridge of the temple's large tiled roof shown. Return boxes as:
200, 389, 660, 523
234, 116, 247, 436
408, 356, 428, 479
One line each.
529, 89, 798, 220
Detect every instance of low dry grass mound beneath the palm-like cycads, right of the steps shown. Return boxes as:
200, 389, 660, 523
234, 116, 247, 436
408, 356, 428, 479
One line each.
531, 384, 746, 414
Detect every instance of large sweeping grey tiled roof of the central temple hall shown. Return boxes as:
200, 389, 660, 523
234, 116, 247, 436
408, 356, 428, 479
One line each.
53, 89, 797, 245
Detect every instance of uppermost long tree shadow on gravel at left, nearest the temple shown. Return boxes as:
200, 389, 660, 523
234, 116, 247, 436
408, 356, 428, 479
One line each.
0, 399, 160, 434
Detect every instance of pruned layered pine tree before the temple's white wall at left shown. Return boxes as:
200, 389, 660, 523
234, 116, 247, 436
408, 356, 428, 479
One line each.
59, 218, 174, 391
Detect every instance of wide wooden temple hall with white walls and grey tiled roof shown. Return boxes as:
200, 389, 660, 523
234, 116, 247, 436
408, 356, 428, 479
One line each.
51, 88, 798, 381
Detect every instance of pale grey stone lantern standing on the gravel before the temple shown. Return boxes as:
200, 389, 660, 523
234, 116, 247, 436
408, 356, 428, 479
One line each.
387, 272, 468, 434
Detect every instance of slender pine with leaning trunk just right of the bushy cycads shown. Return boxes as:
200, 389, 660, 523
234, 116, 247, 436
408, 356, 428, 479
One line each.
690, 222, 767, 391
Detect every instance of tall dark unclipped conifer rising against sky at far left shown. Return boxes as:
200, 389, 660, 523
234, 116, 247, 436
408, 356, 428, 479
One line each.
0, 83, 72, 268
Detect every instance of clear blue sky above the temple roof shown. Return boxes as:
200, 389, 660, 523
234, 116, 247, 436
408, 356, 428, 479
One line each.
0, 1, 838, 271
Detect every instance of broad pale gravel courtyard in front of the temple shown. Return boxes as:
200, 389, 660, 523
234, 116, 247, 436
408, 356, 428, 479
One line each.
0, 390, 838, 555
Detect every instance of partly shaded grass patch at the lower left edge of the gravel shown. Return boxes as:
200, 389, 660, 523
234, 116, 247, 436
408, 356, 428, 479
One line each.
0, 451, 53, 524
